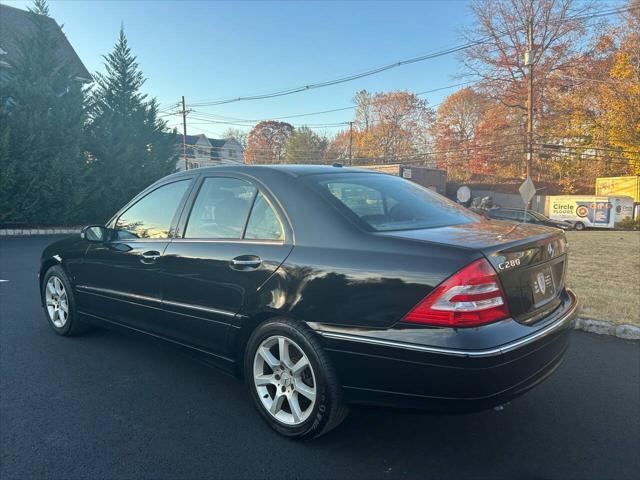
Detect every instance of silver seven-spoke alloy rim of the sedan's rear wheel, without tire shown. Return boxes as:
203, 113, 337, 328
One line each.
253, 335, 317, 425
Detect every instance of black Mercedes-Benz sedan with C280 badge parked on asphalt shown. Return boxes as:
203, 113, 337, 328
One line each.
39, 165, 577, 438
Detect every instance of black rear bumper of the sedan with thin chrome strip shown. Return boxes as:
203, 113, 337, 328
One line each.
311, 290, 577, 411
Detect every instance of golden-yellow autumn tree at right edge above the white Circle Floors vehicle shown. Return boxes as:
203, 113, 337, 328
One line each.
540, 0, 640, 188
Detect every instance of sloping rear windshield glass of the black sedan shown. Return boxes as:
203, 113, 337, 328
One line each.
307, 173, 479, 232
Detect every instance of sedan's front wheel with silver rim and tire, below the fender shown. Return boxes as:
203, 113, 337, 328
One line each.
42, 265, 88, 337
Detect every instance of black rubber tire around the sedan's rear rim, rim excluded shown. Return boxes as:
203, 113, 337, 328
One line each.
244, 318, 349, 440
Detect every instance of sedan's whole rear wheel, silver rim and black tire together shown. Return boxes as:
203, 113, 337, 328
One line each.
245, 319, 348, 439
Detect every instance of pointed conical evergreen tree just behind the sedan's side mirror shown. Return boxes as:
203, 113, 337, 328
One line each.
87, 29, 178, 221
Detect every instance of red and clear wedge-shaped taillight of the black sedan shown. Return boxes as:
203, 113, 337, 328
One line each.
402, 258, 509, 327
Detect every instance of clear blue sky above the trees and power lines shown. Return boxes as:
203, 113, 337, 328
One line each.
3, 0, 616, 136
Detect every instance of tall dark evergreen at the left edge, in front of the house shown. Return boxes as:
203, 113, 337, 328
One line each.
0, 0, 84, 225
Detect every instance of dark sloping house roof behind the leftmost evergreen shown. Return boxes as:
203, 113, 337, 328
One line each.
0, 3, 91, 81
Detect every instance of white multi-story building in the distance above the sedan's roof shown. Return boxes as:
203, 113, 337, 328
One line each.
176, 134, 244, 170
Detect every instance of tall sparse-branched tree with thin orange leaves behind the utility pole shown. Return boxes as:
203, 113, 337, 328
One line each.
462, 0, 596, 183
